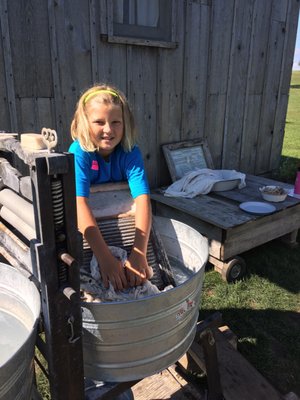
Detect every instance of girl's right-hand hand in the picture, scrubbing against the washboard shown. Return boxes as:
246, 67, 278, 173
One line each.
125, 249, 153, 287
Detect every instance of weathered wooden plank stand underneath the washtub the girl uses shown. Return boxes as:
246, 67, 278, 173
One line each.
87, 312, 299, 400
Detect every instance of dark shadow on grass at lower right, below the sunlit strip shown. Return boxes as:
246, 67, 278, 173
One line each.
200, 308, 300, 396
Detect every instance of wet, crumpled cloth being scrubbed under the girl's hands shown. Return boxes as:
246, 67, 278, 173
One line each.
80, 246, 173, 302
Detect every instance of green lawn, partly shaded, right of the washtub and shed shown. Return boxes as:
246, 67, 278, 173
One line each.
200, 71, 300, 396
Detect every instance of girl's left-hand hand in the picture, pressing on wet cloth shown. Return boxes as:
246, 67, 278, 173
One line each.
98, 253, 128, 290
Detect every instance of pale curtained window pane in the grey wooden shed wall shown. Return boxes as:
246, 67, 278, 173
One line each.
113, 0, 159, 27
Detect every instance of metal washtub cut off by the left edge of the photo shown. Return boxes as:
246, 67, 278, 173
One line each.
0, 263, 40, 400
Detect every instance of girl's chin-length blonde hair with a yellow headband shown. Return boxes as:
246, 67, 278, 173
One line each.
71, 84, 136, 151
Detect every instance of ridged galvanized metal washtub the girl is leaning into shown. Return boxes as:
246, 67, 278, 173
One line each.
82, 217, 208, 382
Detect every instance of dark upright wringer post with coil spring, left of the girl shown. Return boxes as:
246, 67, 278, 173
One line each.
31, 153, 84, 400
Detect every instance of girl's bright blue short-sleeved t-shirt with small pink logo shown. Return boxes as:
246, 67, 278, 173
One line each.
69, 140, 150, 198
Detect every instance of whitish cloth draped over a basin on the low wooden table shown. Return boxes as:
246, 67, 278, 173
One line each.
164, 168, 246, 198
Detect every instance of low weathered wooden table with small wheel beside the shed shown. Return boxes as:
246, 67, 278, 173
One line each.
151, 175, 300, 282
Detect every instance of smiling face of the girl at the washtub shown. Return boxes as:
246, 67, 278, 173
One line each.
87, 101, 124, 158
